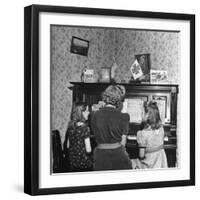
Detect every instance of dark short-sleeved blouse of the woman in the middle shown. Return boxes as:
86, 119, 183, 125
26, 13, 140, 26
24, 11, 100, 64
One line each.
91, 107, 130, 144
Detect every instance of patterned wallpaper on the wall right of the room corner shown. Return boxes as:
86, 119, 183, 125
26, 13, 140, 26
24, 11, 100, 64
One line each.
112, 29, 179, 83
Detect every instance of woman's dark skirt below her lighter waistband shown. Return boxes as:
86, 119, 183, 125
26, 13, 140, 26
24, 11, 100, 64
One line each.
94, 146, 132, 171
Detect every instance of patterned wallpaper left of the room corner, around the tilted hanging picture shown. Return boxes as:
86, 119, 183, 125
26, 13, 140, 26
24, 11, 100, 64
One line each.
51, 26, 115, 141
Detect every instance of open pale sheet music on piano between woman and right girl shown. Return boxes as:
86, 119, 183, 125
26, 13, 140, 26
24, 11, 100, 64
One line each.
122, 98, 144, 123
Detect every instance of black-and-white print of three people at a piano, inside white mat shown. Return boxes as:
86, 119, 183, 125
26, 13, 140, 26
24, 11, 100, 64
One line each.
50, 25, 181, 173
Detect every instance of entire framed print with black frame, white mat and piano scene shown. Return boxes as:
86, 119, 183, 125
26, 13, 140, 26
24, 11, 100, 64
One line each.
24, 5, 195, 195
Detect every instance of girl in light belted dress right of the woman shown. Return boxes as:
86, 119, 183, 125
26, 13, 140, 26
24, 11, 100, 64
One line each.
132, 101, 168, 169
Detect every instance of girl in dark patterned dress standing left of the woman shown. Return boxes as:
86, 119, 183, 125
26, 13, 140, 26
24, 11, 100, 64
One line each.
66, 104, 93, 172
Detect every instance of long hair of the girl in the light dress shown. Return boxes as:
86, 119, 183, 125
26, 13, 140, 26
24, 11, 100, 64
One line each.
146, 101, 161, 130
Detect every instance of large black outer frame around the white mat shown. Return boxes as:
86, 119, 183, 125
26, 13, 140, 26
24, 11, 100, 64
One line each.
24, 5, 195, 195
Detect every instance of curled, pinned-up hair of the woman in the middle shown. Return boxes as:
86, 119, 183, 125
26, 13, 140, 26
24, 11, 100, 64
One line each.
102, 85, 126, 107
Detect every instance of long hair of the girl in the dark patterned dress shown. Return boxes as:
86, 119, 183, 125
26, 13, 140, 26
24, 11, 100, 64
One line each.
69, 103, 87, 126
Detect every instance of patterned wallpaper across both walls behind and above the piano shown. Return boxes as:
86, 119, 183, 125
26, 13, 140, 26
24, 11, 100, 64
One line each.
51, 25, 180, 142
